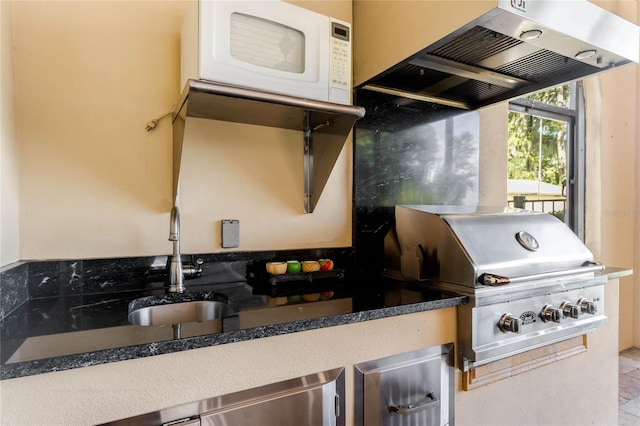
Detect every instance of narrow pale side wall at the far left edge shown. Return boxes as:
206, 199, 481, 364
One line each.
0, 1, 20, 266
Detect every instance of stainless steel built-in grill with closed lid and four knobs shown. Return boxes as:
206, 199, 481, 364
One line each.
385, 206, 607, 371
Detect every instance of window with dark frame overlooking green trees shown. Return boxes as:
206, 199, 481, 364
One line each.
507, 82, 585, 240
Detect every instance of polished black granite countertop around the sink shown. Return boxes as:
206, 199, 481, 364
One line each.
0, 277, 467, 379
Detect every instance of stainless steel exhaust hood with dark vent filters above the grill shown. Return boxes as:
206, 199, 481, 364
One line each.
354, 0, 640, 109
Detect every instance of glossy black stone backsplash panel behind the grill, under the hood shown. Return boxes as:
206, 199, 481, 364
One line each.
353, 88, 480, 274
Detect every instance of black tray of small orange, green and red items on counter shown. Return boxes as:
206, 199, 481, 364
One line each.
247, 259, 345, 305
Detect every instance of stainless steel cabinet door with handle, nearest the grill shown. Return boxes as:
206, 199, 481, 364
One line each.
354, 343, 455, 426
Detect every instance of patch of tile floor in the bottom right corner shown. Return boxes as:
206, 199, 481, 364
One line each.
618, 348, 640, 426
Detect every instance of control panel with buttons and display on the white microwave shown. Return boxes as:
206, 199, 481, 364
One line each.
329, 20, 351, 103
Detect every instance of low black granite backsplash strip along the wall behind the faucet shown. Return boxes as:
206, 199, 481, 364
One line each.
0, 247, 353, 320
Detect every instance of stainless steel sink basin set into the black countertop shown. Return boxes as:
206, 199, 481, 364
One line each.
129, 293, 235, 326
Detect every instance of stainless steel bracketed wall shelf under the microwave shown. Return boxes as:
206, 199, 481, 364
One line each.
173, 80, 365, 213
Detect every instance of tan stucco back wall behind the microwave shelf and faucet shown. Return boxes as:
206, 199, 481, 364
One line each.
3, 1, 351, 260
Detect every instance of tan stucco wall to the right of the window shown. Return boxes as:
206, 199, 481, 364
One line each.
585, 1, 640, 350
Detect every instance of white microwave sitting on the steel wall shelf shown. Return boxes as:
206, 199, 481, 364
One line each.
181, 0, 351, 105
